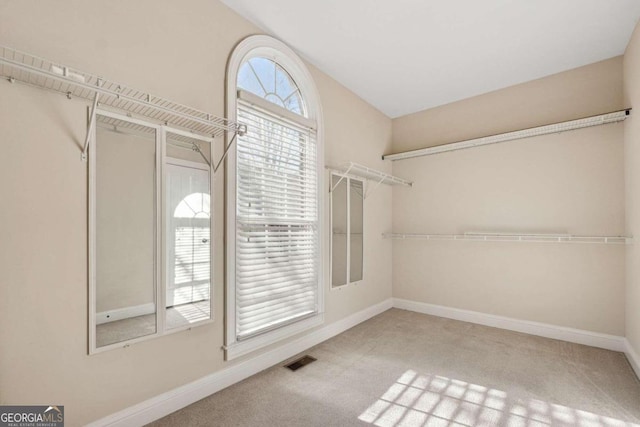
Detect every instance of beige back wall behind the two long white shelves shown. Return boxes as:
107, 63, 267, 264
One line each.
392, 58, 625, 335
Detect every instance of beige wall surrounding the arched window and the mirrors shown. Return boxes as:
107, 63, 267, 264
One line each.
0, 0, 391, 426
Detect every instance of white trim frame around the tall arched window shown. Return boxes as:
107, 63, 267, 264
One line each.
225, 35, 325, 360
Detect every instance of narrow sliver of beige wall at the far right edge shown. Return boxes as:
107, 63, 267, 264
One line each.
624, 25, 640, 354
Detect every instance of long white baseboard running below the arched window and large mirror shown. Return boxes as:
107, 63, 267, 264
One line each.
89, 298, 393, 427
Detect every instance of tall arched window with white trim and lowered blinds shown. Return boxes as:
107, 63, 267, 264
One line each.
226, 36, 323, 359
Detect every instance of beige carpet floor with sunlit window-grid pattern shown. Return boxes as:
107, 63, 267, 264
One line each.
152, 309, 640, 427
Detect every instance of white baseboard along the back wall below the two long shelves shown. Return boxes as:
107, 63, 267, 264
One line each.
393, 298, 624, 352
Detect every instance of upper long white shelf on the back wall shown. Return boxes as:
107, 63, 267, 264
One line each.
382, 108, 631, 160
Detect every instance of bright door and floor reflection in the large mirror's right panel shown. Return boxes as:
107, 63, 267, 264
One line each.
165, 149, 211, 328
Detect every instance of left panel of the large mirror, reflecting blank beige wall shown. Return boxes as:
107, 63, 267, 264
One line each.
95, 116, 156, 347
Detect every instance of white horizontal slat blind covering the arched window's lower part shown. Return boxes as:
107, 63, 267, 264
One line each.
235, 99, 320, 341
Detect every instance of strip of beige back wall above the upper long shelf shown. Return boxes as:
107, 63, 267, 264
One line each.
393, 56, 622, 152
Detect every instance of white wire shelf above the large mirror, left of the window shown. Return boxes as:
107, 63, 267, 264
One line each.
0, 46, 242, 137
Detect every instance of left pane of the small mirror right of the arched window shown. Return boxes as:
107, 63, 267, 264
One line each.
331, 175, 348, 287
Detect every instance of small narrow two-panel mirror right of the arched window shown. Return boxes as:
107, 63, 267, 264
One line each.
331, 174, 364, 288
